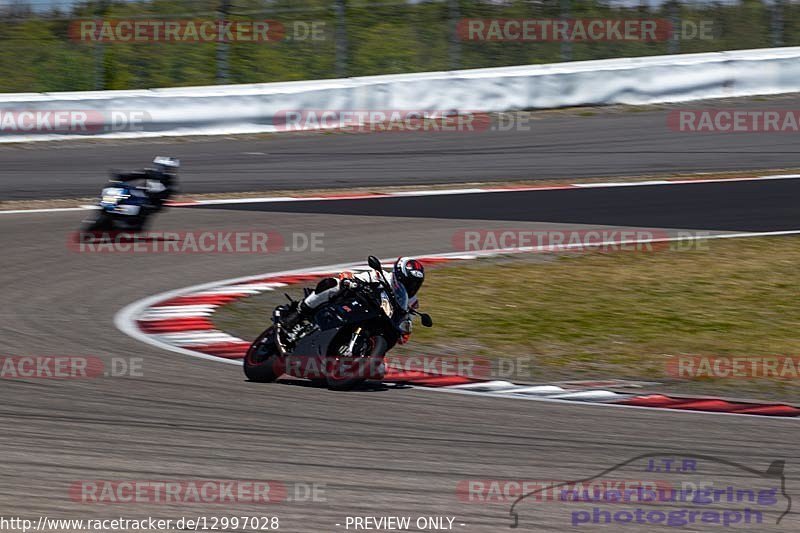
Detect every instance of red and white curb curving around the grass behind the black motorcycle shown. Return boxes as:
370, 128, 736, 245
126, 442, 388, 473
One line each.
114, 243, 800, 417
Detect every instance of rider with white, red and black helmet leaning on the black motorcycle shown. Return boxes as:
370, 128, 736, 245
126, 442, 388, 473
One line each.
275, 257, 425, 344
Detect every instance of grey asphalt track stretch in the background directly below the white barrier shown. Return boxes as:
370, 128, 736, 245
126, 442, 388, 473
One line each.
0, 96, 800, 200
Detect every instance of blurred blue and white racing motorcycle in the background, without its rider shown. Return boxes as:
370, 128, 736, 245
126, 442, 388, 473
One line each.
82, 180, 161, 232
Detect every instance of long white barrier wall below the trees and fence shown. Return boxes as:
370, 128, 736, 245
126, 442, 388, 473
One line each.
0, 47, 800, 142
